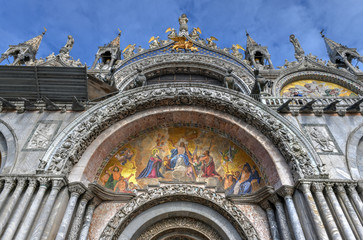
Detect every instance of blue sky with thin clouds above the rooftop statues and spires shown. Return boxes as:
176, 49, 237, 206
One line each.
0, 0, 363, 67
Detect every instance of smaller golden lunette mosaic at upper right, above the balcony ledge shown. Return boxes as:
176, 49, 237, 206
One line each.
280, 80, 357, 97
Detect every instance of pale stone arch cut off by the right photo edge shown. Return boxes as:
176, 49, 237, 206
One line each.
346, 124, 363, 180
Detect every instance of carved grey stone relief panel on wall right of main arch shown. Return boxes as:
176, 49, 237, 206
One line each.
302, 124, 343, 155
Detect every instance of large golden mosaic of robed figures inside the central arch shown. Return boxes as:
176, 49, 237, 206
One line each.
97, 127, 266, 195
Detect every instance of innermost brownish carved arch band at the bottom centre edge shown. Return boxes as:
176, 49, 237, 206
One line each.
137, 217, 222, 240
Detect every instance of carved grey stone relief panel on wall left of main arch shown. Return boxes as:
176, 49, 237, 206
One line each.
23, 120, 62, 151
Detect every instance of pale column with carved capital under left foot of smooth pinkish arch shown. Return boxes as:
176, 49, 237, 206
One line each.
56, 183, 86, 240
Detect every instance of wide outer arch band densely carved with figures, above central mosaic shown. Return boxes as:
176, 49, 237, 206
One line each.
39, 84, 321, 180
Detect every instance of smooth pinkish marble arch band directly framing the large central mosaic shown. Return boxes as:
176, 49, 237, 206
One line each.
69, 106, 294, 189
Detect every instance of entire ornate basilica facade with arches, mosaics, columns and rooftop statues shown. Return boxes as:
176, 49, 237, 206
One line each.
0, 14, 363, 240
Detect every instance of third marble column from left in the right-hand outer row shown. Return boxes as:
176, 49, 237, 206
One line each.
325, 183, 355, 239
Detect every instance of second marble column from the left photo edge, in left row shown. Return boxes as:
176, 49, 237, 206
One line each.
0, 178, 26, 235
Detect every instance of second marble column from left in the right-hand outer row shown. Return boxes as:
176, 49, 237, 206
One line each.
311, 183, 342, 240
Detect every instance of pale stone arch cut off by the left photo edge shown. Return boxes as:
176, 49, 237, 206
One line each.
0, 120, 17, 173
